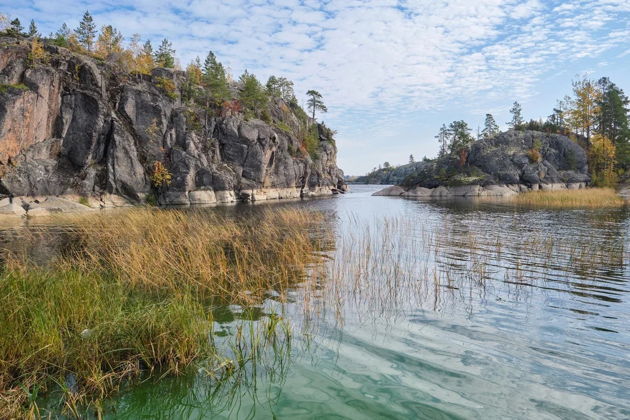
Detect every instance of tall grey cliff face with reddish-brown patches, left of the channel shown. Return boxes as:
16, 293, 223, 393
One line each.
0, 39, 345, 213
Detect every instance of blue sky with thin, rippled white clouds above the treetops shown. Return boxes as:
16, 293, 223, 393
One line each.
0, 0, 630, 175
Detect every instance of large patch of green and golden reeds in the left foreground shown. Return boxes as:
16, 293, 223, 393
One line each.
0, 210, 318, 417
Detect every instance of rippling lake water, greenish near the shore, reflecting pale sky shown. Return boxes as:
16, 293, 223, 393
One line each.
0, 186, 630, 419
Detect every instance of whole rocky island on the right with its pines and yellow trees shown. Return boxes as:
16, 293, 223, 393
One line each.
352, 77, 630, 201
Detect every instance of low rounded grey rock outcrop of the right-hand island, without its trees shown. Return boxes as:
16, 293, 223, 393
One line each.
379, 130, 590, 196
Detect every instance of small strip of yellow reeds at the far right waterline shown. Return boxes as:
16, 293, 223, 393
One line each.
513, 188, 625, 208
